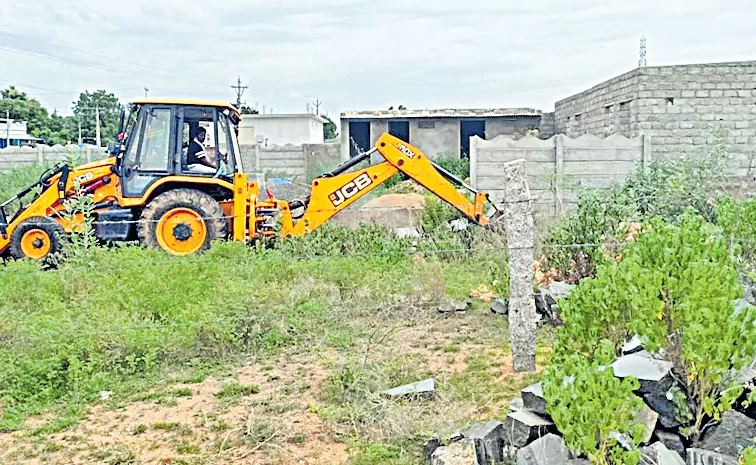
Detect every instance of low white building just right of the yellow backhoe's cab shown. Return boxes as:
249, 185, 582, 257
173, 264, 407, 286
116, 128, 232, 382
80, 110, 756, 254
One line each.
239, 113, 327, 146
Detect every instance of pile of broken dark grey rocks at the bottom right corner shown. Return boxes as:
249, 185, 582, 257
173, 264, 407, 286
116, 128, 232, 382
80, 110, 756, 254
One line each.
425, 340, 756, 465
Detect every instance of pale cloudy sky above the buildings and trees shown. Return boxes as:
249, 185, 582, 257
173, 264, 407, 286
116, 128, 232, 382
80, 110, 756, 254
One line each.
0, 0, 756, 117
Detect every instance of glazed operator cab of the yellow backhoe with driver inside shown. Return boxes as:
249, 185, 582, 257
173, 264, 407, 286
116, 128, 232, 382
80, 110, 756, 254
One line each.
117, 99, 242, 197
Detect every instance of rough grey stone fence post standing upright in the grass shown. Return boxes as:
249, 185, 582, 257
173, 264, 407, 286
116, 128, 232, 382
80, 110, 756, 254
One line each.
504, 159, 537, 372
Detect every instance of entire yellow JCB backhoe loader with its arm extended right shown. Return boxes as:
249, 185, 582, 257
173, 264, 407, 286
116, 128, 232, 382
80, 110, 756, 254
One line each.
0, 99, 495, 260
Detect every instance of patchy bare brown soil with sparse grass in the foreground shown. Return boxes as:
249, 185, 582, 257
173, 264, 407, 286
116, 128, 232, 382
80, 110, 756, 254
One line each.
0, 309, 548, 465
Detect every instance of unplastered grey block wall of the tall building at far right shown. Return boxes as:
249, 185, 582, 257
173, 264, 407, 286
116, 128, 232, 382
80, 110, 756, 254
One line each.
555, 61, 756, 183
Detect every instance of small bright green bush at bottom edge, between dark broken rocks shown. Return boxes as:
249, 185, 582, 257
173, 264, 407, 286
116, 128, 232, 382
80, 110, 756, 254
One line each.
543, 340, 645, 465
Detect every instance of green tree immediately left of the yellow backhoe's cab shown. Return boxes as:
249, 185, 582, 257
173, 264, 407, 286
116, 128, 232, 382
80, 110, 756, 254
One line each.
73, 90, 121, 144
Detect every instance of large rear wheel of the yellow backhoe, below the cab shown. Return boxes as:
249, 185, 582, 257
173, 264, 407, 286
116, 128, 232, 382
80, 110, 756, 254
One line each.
137, 189, 226, 256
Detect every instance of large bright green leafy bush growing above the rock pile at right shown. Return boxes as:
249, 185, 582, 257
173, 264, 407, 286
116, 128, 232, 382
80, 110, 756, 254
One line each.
555, 212, 756, 441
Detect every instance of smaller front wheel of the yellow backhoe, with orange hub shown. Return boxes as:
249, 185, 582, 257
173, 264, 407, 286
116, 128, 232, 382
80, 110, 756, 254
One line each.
9, 216, 65, 262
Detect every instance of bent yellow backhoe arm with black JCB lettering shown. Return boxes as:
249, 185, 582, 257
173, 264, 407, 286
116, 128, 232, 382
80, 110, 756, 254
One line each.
281, 133, 496, 237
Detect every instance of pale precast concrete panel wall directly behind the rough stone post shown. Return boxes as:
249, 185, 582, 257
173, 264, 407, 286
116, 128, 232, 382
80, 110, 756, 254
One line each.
470, 134, 651, 216
